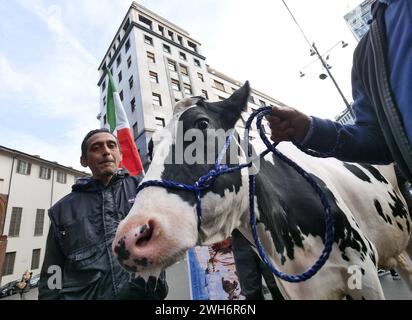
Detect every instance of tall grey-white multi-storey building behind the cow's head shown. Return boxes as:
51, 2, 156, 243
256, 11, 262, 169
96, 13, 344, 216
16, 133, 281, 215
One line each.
98, 2, 281, 164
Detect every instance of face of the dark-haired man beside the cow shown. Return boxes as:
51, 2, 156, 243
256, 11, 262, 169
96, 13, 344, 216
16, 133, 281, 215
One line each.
80, 132, 122, 182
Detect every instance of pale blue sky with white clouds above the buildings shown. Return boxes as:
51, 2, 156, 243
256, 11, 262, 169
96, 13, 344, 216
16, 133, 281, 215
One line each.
0, 0, 361, 171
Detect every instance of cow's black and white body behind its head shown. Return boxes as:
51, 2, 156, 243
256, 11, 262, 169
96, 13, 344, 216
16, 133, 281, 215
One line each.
240, 142, 411, 299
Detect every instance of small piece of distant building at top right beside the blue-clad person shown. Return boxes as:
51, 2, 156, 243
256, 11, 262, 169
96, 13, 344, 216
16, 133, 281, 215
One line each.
344, 0, 373, 41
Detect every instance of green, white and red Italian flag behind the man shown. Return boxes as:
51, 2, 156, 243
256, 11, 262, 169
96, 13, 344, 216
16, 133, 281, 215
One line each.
106, 70, 144, 176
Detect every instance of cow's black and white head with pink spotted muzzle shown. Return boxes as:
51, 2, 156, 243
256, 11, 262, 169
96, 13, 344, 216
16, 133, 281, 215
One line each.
113, 82, 250, 273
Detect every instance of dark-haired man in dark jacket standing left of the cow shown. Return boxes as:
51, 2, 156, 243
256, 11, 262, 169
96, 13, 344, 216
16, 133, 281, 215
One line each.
39, 129, 168, 300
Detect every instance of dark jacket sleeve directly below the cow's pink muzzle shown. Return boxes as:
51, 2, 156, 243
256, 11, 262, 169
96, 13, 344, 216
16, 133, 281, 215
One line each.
117, 271, 169, 300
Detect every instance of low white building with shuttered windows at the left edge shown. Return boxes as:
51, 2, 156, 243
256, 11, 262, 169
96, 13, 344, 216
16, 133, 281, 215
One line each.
0, 146, 87, 285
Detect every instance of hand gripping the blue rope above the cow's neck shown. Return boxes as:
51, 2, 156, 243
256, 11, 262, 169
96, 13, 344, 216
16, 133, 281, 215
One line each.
266, 107, 310, 143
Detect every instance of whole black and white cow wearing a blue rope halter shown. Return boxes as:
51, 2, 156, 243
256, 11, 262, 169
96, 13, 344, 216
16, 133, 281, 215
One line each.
113, 83, 412, 299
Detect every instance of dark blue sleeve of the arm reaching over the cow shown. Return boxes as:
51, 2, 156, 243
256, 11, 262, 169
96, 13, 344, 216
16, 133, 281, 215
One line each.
303, 69, 393, 164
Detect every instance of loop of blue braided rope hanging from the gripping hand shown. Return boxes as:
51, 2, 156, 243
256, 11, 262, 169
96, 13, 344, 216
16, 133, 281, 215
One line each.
246, 107, 335, 282
